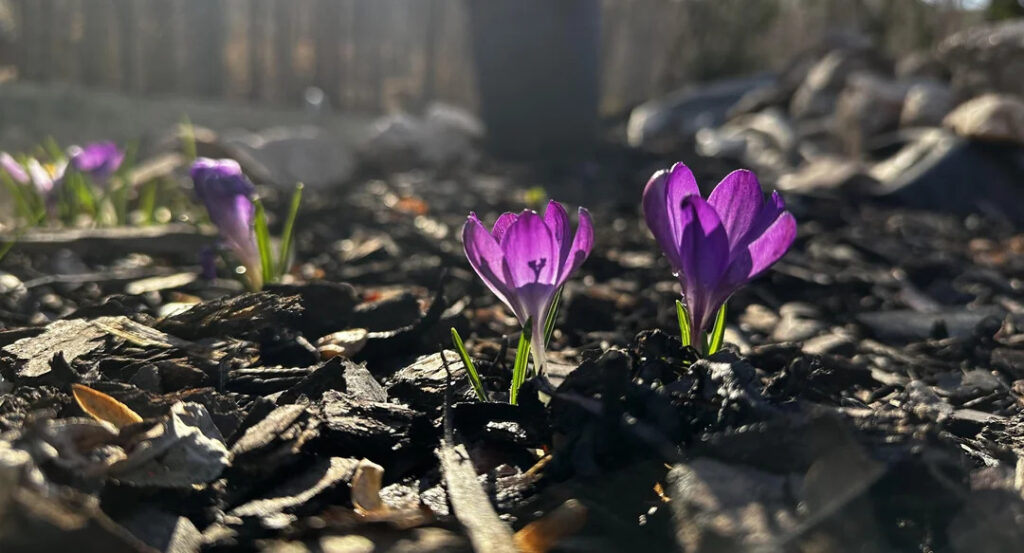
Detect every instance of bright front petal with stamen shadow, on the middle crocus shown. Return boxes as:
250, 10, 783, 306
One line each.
501, 211, 561, 318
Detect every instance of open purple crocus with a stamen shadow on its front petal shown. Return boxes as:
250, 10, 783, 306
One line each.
462, 201, 594, 373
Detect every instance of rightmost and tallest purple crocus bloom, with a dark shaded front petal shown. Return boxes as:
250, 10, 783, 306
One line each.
643, 163, 797, 346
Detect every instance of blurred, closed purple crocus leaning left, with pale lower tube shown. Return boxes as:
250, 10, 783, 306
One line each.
190, 158, 263, 290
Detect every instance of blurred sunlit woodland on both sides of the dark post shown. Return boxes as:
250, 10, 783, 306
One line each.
0, 0, 974, 113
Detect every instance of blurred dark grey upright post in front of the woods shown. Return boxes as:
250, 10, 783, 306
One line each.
468, 0, 601, 158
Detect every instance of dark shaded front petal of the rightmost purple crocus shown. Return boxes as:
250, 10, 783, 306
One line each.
680, 196, 729, 337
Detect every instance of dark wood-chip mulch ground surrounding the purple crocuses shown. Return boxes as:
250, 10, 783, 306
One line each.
0, 150, 1024, 553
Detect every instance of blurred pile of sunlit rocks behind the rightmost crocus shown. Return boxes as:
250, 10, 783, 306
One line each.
628, 20, 1024, 221
